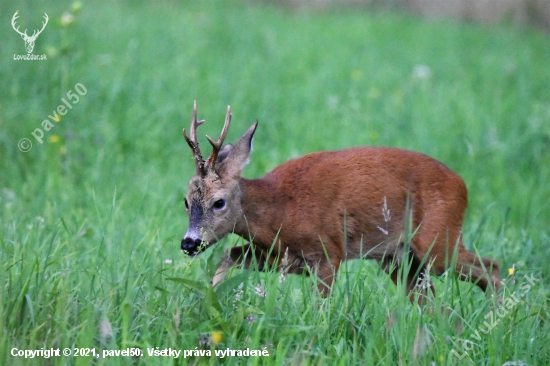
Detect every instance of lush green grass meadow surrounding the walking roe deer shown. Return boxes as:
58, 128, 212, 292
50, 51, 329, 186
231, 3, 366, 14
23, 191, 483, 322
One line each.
0, 0, 550, 365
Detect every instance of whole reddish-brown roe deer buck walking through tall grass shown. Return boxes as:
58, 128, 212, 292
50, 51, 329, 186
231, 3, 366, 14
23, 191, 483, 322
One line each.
181, 102, 500, 302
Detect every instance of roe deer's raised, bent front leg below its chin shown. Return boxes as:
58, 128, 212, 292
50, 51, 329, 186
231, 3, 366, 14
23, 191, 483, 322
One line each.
212, 244, 273, 286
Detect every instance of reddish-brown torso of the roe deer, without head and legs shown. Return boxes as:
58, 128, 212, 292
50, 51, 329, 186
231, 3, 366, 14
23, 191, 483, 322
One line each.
235, 147, 467, 259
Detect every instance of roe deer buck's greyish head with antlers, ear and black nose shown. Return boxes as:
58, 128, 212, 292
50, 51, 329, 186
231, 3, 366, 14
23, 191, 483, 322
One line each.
181, 101, 258, 255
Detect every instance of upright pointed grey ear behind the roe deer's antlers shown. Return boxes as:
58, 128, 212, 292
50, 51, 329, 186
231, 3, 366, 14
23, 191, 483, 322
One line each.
218, 121, 258, 177
